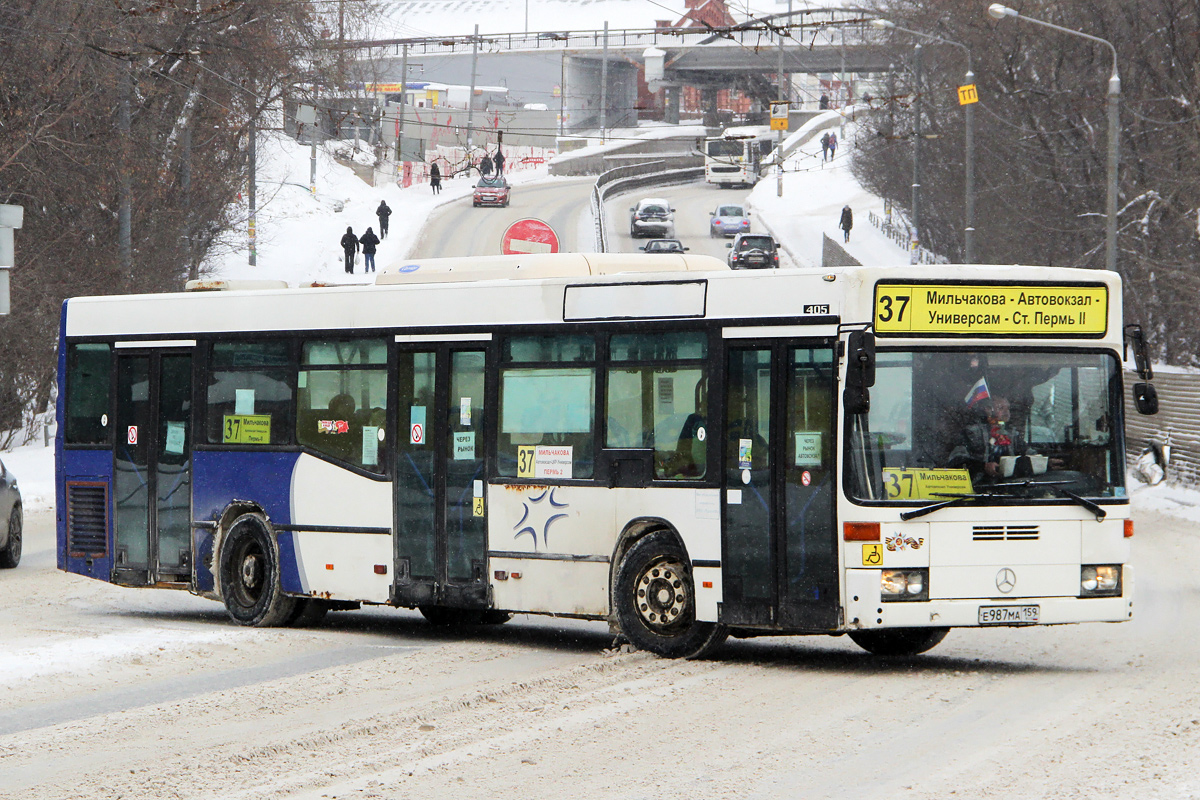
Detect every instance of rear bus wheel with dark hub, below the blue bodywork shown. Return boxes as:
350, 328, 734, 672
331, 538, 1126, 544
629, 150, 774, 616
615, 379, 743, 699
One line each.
220, 513, 296, 627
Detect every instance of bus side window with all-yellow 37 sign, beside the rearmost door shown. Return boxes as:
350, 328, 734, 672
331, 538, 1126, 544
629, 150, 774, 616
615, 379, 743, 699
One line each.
205, 341, 294, 446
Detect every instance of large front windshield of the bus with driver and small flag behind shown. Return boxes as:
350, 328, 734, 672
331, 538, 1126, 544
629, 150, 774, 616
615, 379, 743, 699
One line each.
846, 350, 1124, 504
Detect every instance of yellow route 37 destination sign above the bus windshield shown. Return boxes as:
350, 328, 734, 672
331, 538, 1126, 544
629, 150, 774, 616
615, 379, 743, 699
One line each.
875, 282, 1109, 336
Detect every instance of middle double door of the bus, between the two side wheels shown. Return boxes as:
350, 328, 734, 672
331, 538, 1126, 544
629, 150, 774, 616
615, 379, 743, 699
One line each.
394, 344, 491, 608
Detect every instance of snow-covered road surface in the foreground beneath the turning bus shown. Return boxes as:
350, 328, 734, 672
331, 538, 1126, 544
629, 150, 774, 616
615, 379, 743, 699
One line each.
0, 512, 1200, 800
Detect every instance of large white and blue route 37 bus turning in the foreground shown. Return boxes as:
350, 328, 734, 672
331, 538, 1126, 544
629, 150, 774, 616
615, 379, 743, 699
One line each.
56, 254, 1154, 657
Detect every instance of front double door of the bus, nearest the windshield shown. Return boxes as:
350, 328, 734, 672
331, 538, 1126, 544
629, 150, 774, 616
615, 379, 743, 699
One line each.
720, 339, 838, 631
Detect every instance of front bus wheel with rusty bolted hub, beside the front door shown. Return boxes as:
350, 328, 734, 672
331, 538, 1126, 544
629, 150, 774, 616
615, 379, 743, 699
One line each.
613, 530, 728, 658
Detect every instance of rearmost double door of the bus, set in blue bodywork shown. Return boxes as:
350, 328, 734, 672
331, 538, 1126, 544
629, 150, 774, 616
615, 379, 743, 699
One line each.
113, 343, 192, 587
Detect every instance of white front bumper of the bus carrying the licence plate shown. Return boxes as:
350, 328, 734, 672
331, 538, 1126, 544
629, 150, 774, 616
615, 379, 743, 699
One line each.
846, 565, 1134, 630
